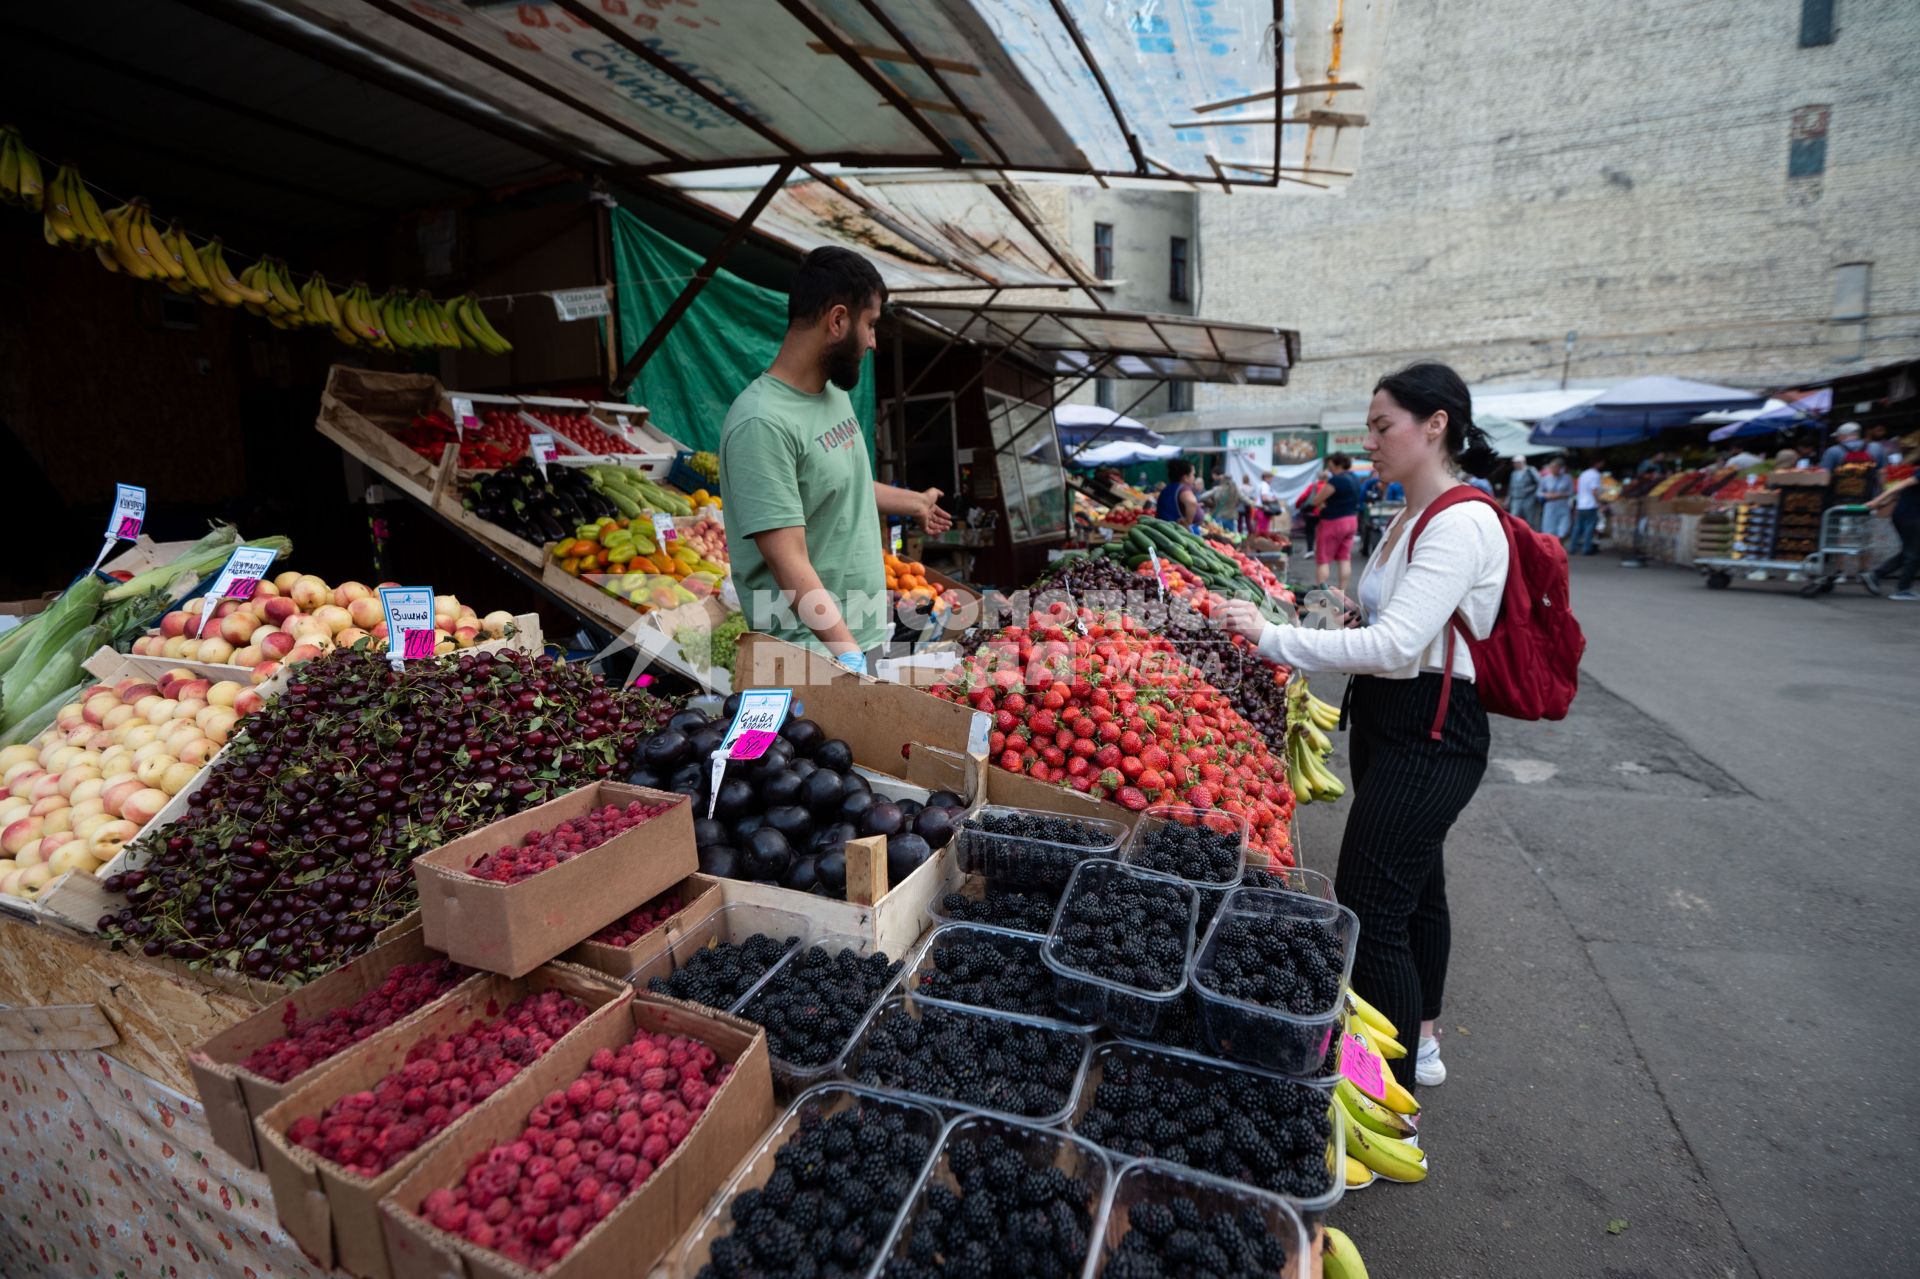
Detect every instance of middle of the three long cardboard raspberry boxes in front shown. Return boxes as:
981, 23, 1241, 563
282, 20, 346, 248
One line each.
253, 964, 634, 1279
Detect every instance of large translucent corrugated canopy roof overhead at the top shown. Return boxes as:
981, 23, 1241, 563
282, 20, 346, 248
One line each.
251, 0, 1386, 188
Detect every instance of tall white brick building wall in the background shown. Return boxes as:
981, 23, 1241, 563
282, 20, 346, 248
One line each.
1196, 0, 1920, 422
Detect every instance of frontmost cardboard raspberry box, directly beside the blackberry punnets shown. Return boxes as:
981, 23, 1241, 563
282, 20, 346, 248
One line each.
380, 997, 778, 1279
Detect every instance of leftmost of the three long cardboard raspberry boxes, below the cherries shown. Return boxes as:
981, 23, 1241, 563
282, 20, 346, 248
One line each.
186, 928, 484, 1168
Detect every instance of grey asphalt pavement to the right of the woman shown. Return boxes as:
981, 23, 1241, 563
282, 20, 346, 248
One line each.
1294, 553, 1920, 1279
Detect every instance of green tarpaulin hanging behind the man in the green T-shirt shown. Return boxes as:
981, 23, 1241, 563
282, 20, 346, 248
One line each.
612, 209, 874, 459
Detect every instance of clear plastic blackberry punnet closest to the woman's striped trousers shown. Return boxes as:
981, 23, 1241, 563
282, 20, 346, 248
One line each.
1192, 887, 1359, 1077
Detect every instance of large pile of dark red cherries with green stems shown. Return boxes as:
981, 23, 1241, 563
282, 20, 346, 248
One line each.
98, 651, 639, 981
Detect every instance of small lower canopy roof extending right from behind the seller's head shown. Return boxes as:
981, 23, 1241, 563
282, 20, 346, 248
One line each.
895, 302, 1300, 386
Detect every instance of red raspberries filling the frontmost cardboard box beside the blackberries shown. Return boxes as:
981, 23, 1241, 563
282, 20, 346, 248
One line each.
419, 1031, 733, 1269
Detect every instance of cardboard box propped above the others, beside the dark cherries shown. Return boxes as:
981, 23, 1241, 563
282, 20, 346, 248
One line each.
413, 782, 699, 977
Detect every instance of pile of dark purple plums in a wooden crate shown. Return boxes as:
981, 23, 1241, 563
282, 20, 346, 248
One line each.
628, 693, 964, 897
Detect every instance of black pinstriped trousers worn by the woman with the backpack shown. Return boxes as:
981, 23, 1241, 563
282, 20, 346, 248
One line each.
1334, 670, 1488, 1089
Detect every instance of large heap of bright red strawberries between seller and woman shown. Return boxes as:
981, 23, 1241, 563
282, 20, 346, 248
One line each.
935, 601, 1294, 866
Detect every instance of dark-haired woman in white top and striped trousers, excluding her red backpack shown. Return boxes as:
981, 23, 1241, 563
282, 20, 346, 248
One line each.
1213, 363, 1507, 1089
